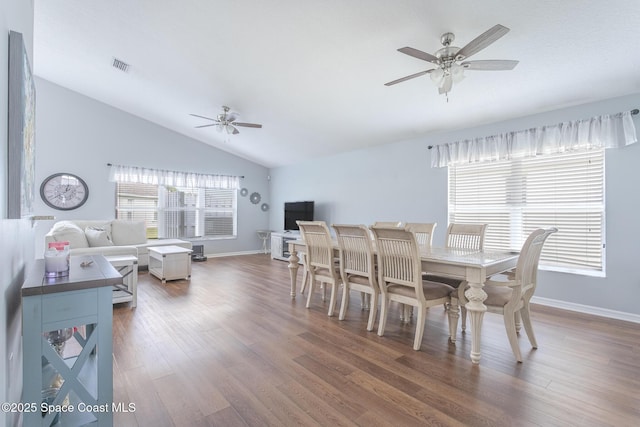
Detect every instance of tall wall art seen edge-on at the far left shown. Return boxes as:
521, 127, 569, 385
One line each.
7, 31, 36, 219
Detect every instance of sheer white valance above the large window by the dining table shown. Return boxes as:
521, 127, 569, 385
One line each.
431, 111, 638, 168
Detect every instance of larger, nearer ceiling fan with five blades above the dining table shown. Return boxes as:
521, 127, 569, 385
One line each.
385, 24, 518, 94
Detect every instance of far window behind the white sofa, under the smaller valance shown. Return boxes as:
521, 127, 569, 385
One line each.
116, 182, 237, 239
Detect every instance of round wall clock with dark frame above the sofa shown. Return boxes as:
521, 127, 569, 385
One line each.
40, 173, 89, 211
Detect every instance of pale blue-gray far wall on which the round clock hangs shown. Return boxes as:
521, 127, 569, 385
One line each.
35, 78, 270, 258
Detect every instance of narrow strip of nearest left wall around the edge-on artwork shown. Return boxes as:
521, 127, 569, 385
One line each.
0, 0, 37, 426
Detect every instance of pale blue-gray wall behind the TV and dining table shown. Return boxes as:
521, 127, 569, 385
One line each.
270, 94, 640, 319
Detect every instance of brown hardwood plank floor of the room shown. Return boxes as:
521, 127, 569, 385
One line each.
113, 255, 640, 427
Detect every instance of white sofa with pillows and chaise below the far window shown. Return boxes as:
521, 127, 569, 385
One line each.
45, 219, 192, 268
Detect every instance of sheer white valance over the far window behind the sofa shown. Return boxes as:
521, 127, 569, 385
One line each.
109, 165, 240, 190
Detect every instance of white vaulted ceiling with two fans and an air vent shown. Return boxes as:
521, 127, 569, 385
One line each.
33, 0, 640, 167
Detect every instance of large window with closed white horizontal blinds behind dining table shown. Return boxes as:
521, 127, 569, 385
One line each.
449, 149, 605, 275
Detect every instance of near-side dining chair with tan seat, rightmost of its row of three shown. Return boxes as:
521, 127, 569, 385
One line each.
371, 227, 458, 350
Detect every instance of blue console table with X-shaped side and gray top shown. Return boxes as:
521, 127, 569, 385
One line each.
22, 255, 123, 427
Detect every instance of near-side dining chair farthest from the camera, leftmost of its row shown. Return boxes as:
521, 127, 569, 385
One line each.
296, 221, 341, 316
